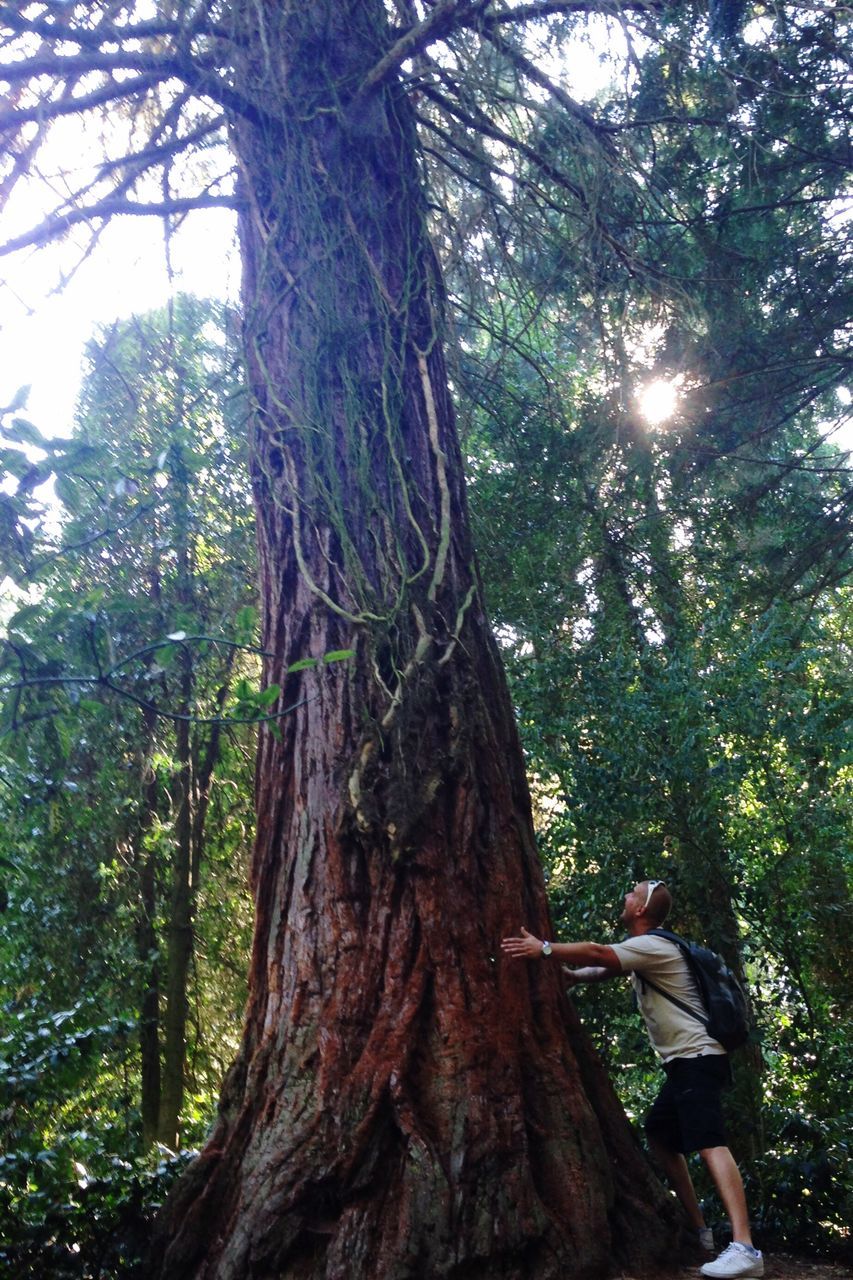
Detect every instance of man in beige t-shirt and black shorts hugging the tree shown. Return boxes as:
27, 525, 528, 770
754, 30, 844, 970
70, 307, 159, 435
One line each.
501, 881, 765, 1280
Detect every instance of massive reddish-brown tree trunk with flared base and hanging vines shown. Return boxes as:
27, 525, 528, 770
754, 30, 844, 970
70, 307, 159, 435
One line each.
152, 0, 674, 1280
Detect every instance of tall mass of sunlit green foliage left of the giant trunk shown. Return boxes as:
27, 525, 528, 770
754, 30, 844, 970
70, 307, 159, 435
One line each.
0, 300, 256, 1254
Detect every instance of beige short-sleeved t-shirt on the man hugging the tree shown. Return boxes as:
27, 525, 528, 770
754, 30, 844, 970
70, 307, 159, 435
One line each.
612, 933, 725, 1062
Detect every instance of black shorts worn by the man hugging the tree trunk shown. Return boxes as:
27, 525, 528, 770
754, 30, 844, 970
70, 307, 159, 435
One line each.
646, 1053, 731, 1156
